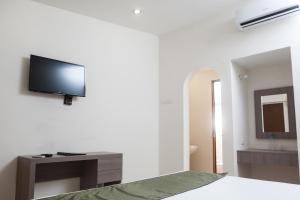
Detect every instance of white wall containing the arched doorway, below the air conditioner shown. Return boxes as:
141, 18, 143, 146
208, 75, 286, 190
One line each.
159, 9, 300, 174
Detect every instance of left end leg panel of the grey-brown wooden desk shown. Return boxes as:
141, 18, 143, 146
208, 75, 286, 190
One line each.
15, 158, 35, 200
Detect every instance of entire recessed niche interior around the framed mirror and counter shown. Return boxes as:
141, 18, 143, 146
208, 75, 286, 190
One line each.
232, 48, 299, 183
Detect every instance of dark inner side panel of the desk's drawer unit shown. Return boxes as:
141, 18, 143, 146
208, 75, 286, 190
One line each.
80, 160, 98, 190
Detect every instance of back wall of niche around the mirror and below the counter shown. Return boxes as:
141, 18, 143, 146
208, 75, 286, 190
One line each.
247, 60, 299, 183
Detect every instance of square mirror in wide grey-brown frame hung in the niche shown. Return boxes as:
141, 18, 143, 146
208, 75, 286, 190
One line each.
254, 87, 296, 139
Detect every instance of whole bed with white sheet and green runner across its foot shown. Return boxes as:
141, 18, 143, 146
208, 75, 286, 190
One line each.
40, 171, 300, 200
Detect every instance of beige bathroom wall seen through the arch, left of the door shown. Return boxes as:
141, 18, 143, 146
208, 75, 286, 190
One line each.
189, 70, 219, 172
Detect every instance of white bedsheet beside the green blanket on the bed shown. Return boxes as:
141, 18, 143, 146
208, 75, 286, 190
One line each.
165, 176, 300, 200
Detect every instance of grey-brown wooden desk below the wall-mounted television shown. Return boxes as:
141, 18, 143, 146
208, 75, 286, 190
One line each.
15, 152, 123, 200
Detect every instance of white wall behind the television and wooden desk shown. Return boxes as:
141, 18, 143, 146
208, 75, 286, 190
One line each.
0, 0, 159, 200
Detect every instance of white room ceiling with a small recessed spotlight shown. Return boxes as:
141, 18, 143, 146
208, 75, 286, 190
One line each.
35, 0, 239, 35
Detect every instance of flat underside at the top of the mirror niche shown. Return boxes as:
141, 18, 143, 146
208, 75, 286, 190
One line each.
233, 47, 292, 69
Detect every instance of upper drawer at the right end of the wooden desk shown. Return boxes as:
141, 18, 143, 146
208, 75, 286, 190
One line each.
98, 157, 122, 171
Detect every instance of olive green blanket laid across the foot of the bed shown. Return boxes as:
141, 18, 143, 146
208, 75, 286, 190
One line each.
41, 171, 223, 200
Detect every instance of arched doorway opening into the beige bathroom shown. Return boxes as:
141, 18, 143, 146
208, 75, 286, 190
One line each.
189, 69, 223, 173
